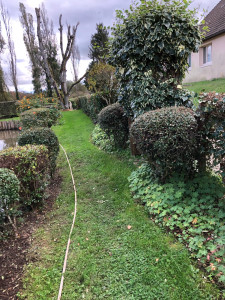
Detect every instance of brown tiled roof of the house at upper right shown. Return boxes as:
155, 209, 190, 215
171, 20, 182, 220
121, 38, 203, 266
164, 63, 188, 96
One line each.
204, 0, 225, 40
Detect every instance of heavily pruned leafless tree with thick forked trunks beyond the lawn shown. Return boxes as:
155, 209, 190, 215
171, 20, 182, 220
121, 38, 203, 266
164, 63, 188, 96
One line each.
35, 8, 86, 109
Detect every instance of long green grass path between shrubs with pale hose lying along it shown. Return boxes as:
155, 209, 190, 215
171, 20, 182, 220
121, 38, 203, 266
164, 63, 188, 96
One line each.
20, 111, 219, 300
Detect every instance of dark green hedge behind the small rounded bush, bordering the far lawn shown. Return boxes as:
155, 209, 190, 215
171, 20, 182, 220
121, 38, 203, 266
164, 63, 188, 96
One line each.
79, 94, 106, 122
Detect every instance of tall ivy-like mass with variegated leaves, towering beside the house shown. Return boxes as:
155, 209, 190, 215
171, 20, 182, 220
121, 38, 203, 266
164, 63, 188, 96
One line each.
109, 0, 201, 117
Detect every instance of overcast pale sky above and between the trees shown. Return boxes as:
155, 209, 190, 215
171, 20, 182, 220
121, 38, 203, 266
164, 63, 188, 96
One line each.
1, 0, 220, 91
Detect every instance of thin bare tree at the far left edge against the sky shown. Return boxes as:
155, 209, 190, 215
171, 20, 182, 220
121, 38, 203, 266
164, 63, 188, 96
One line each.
0, 2, 19, 100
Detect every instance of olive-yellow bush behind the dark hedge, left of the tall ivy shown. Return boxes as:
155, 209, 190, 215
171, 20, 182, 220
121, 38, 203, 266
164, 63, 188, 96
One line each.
86, 62, 118, 105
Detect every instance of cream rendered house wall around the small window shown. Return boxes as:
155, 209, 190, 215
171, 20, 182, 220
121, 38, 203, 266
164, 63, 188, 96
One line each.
184, 34, 225, 83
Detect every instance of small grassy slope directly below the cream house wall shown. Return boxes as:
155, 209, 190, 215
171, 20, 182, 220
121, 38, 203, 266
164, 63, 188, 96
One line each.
183, 78, 225, 93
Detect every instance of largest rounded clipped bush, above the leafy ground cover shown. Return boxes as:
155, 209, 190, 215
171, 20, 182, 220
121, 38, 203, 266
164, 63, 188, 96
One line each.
130, 107, 197, 178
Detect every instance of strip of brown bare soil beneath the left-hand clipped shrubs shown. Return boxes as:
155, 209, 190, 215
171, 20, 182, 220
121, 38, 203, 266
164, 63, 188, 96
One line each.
0, 172, 61, 300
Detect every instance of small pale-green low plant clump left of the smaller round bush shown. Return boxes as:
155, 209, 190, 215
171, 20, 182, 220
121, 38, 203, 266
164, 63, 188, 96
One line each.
91, 124, 115, 152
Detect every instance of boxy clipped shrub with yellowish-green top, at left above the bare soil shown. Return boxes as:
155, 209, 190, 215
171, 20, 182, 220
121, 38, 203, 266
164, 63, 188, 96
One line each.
0, 145, 49, 205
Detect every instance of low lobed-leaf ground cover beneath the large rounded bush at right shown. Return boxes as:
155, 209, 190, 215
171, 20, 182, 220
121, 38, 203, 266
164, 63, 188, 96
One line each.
129, 164, 225, 284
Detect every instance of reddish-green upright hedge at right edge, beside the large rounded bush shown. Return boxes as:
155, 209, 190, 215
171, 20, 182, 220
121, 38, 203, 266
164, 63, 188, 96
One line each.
194, 92, 225, 177
